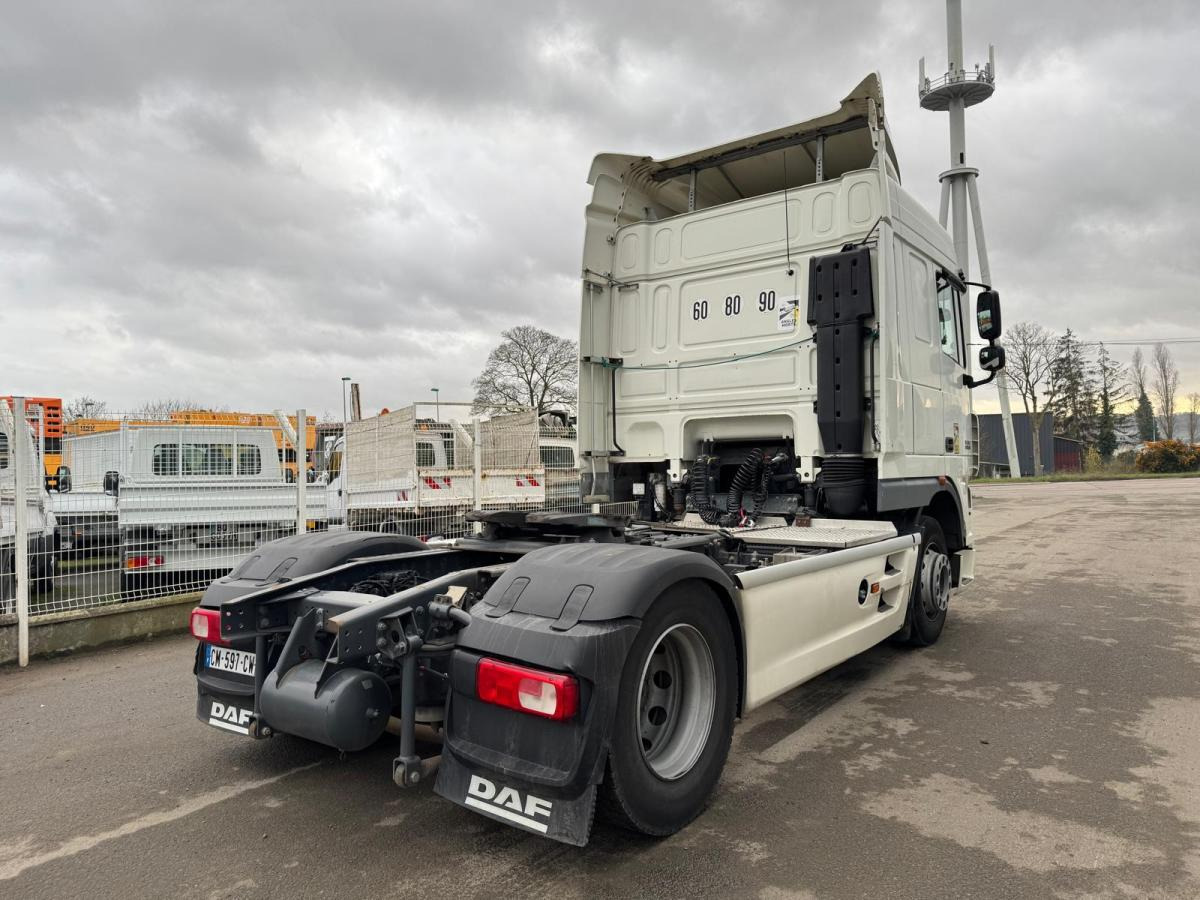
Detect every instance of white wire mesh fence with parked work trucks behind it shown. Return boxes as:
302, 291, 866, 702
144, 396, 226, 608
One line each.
0, 398, 632, 667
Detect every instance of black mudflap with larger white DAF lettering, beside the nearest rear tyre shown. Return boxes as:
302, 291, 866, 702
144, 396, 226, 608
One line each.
433, 752, 596, 847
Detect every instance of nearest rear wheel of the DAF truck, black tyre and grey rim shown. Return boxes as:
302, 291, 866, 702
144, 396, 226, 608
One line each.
598, 582, 738, 835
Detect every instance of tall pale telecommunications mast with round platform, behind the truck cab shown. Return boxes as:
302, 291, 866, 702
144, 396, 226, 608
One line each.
917, 0, 1021, 478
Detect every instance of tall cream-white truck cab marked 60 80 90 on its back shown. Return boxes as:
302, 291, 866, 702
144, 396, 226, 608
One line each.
580, 74, 988, 583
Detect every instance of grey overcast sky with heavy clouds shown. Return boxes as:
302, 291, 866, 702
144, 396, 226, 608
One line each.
0, 0, 1200, 415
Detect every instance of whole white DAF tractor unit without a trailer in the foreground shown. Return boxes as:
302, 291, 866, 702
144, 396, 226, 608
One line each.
192, 76, 1002, 845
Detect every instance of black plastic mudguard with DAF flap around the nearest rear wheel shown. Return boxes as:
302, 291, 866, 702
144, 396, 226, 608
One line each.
434, 544, 732, 846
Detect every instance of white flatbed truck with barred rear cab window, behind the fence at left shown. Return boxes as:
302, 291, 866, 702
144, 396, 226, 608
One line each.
50, 422, 296, 598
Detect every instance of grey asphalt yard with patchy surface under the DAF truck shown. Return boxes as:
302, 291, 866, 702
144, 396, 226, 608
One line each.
0, 480, 1200, 899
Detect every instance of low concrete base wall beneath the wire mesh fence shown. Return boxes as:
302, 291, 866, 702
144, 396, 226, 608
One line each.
0, 593, 200, 665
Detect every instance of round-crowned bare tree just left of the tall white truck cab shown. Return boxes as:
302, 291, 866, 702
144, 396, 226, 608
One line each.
472, 325, 580, 415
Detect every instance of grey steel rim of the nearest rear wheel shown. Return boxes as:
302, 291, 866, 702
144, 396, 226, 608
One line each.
637, 624, 716, 781
